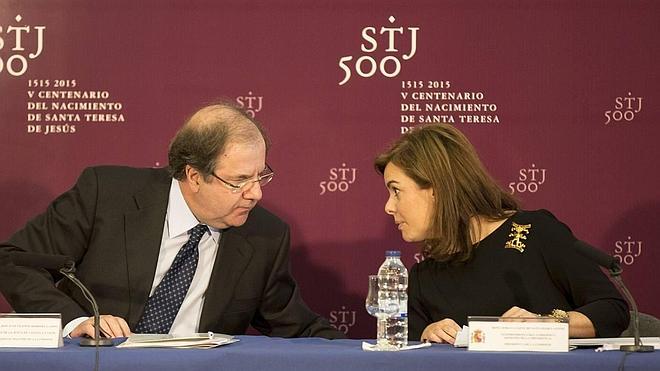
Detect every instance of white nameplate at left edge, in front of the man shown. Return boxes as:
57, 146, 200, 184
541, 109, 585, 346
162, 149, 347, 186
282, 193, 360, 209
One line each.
0, 313, 62, 348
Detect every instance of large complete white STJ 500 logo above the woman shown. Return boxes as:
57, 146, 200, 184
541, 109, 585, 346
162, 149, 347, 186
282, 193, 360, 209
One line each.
339, 16, 419, 85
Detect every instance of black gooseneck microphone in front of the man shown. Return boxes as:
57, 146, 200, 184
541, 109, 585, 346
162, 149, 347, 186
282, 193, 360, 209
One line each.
10, 251, 113, 347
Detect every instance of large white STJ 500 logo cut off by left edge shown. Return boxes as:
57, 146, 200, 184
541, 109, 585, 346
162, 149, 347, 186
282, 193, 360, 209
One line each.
0, 14, 46, 76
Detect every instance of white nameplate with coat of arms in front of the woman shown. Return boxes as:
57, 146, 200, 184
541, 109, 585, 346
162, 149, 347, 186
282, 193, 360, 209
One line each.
468, 317, 569, 352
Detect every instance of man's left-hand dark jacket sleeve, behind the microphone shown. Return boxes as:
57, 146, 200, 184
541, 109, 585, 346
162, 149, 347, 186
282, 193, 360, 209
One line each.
0, 168, 97, 323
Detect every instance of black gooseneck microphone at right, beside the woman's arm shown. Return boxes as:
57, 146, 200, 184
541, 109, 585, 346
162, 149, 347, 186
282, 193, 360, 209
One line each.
574, 240, 655, 352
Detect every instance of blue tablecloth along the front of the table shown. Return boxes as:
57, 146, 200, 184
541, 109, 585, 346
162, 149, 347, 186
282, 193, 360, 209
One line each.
0, 336, 660, 371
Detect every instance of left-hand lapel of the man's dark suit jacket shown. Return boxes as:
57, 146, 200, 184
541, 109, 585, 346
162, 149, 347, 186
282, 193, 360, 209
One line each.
124, 173, 171, 327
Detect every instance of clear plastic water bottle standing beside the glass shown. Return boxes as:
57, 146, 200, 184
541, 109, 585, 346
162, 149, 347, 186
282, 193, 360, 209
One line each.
378, 251, 408, 349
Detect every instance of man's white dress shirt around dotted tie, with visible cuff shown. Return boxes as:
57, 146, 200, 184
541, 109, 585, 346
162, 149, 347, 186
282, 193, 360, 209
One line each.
62, 179, 220, 336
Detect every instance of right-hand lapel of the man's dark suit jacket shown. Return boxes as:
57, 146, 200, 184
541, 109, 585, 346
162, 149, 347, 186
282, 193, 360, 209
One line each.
199, 228, 254, 330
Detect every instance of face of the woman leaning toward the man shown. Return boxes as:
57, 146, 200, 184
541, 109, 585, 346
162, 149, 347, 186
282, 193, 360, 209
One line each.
383, 163, 435, 242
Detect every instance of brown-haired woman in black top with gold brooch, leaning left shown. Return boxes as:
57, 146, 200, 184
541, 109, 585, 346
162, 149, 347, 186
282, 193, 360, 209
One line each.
375, 124, 629, 344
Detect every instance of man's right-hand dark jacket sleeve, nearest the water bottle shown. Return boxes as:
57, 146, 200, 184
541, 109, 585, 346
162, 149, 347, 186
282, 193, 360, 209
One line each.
252, 228, 345, 339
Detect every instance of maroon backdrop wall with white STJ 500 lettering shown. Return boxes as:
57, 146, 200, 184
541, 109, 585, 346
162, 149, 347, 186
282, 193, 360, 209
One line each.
0, 0, 660, 338
